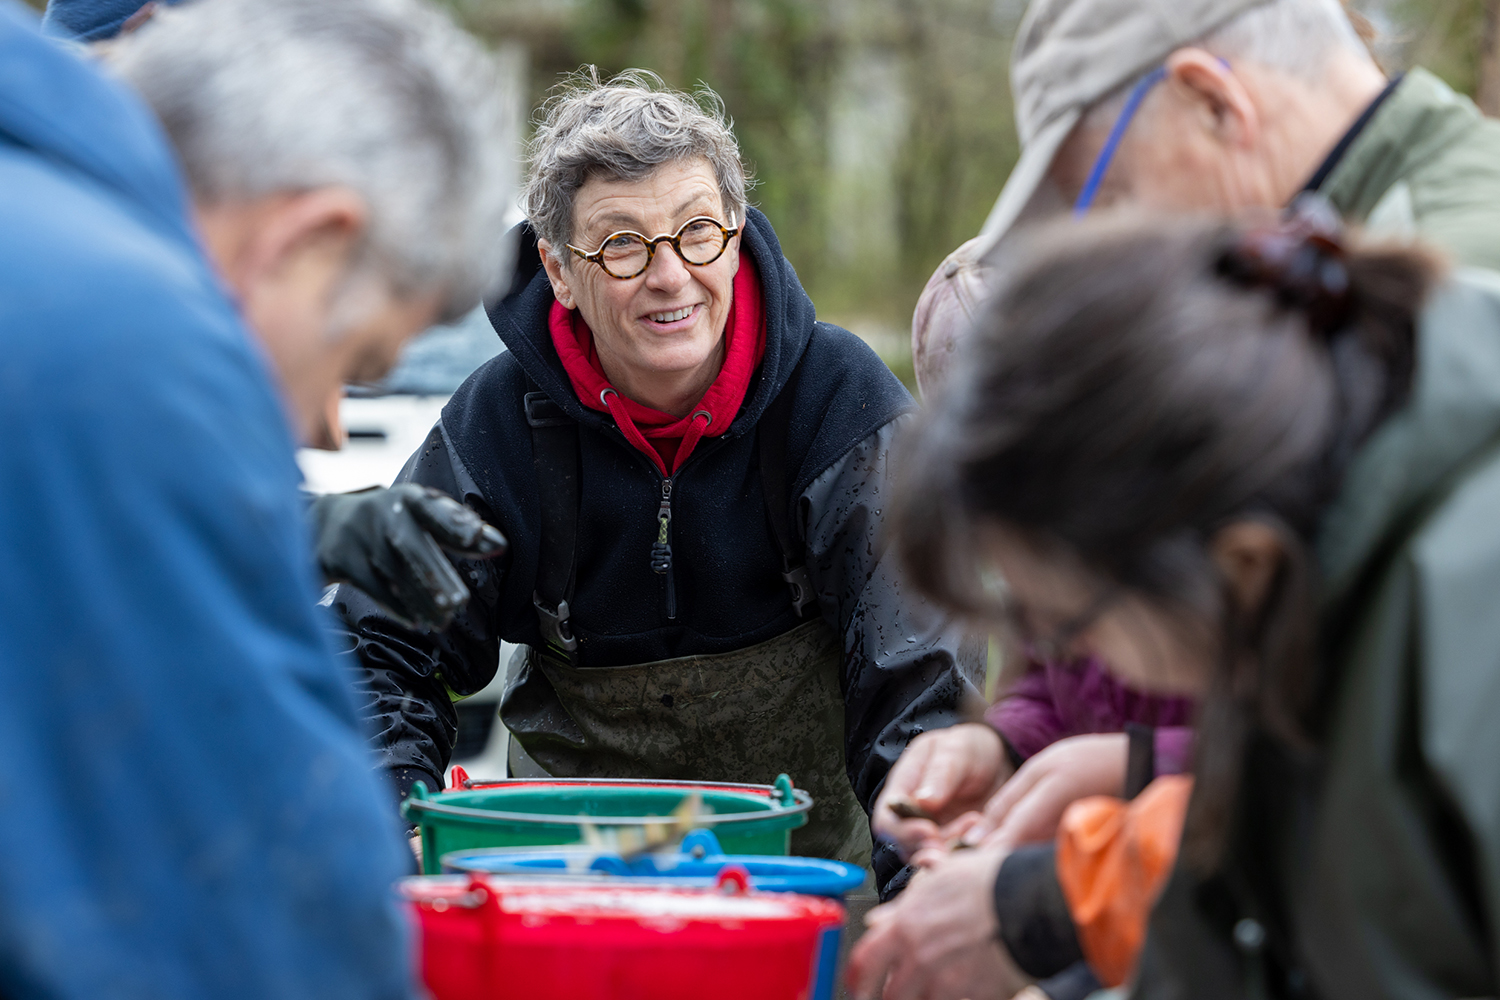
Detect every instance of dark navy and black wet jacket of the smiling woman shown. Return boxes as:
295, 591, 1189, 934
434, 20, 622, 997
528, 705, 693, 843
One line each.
335, 217, 978, 839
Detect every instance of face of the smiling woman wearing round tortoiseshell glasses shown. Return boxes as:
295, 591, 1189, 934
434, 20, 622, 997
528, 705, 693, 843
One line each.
545, 157, 743, 388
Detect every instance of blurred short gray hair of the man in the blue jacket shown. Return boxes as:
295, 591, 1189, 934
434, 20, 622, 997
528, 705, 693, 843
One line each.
104, 0, 518, 316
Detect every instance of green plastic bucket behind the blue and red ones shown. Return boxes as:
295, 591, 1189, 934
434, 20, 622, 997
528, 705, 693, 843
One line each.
401, 774, 813, 876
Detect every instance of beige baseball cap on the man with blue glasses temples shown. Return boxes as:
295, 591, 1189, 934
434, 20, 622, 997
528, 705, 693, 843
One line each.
981, 0, 1269, 246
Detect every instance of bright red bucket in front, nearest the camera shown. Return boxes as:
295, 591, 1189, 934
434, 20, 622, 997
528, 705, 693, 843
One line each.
402, 868, 845, 1000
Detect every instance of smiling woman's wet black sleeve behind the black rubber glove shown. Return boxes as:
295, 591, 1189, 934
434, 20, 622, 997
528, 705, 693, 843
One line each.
332, 421, 509, 798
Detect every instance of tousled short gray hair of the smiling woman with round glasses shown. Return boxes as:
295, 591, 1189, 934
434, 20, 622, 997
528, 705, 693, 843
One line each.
525, 66, 750, 256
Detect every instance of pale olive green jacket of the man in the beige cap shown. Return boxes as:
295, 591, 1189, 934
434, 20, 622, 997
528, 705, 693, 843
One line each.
1319, 69, 1500, 268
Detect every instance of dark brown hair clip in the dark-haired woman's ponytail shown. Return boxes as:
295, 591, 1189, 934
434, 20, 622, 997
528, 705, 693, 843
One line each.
1215, 199, 1353, 336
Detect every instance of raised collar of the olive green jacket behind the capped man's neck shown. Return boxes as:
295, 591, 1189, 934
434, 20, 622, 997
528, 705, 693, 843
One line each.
1319, 67, 1482, 222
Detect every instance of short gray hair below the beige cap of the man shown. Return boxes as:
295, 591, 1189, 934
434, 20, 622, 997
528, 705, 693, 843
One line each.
1086, 0, 1374, 127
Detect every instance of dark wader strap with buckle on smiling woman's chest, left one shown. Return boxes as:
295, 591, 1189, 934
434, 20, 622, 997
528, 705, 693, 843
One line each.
525, 393, 579, 663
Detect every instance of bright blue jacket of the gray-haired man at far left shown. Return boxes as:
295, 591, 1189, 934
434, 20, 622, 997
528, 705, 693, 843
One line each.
0, 0, 413, 1000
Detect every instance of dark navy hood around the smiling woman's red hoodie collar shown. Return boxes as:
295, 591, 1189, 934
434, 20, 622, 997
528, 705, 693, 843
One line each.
488, 208, 818, 438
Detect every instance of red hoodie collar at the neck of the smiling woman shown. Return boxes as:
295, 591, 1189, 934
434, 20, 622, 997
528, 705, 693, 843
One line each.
548, 255, 765, 478
